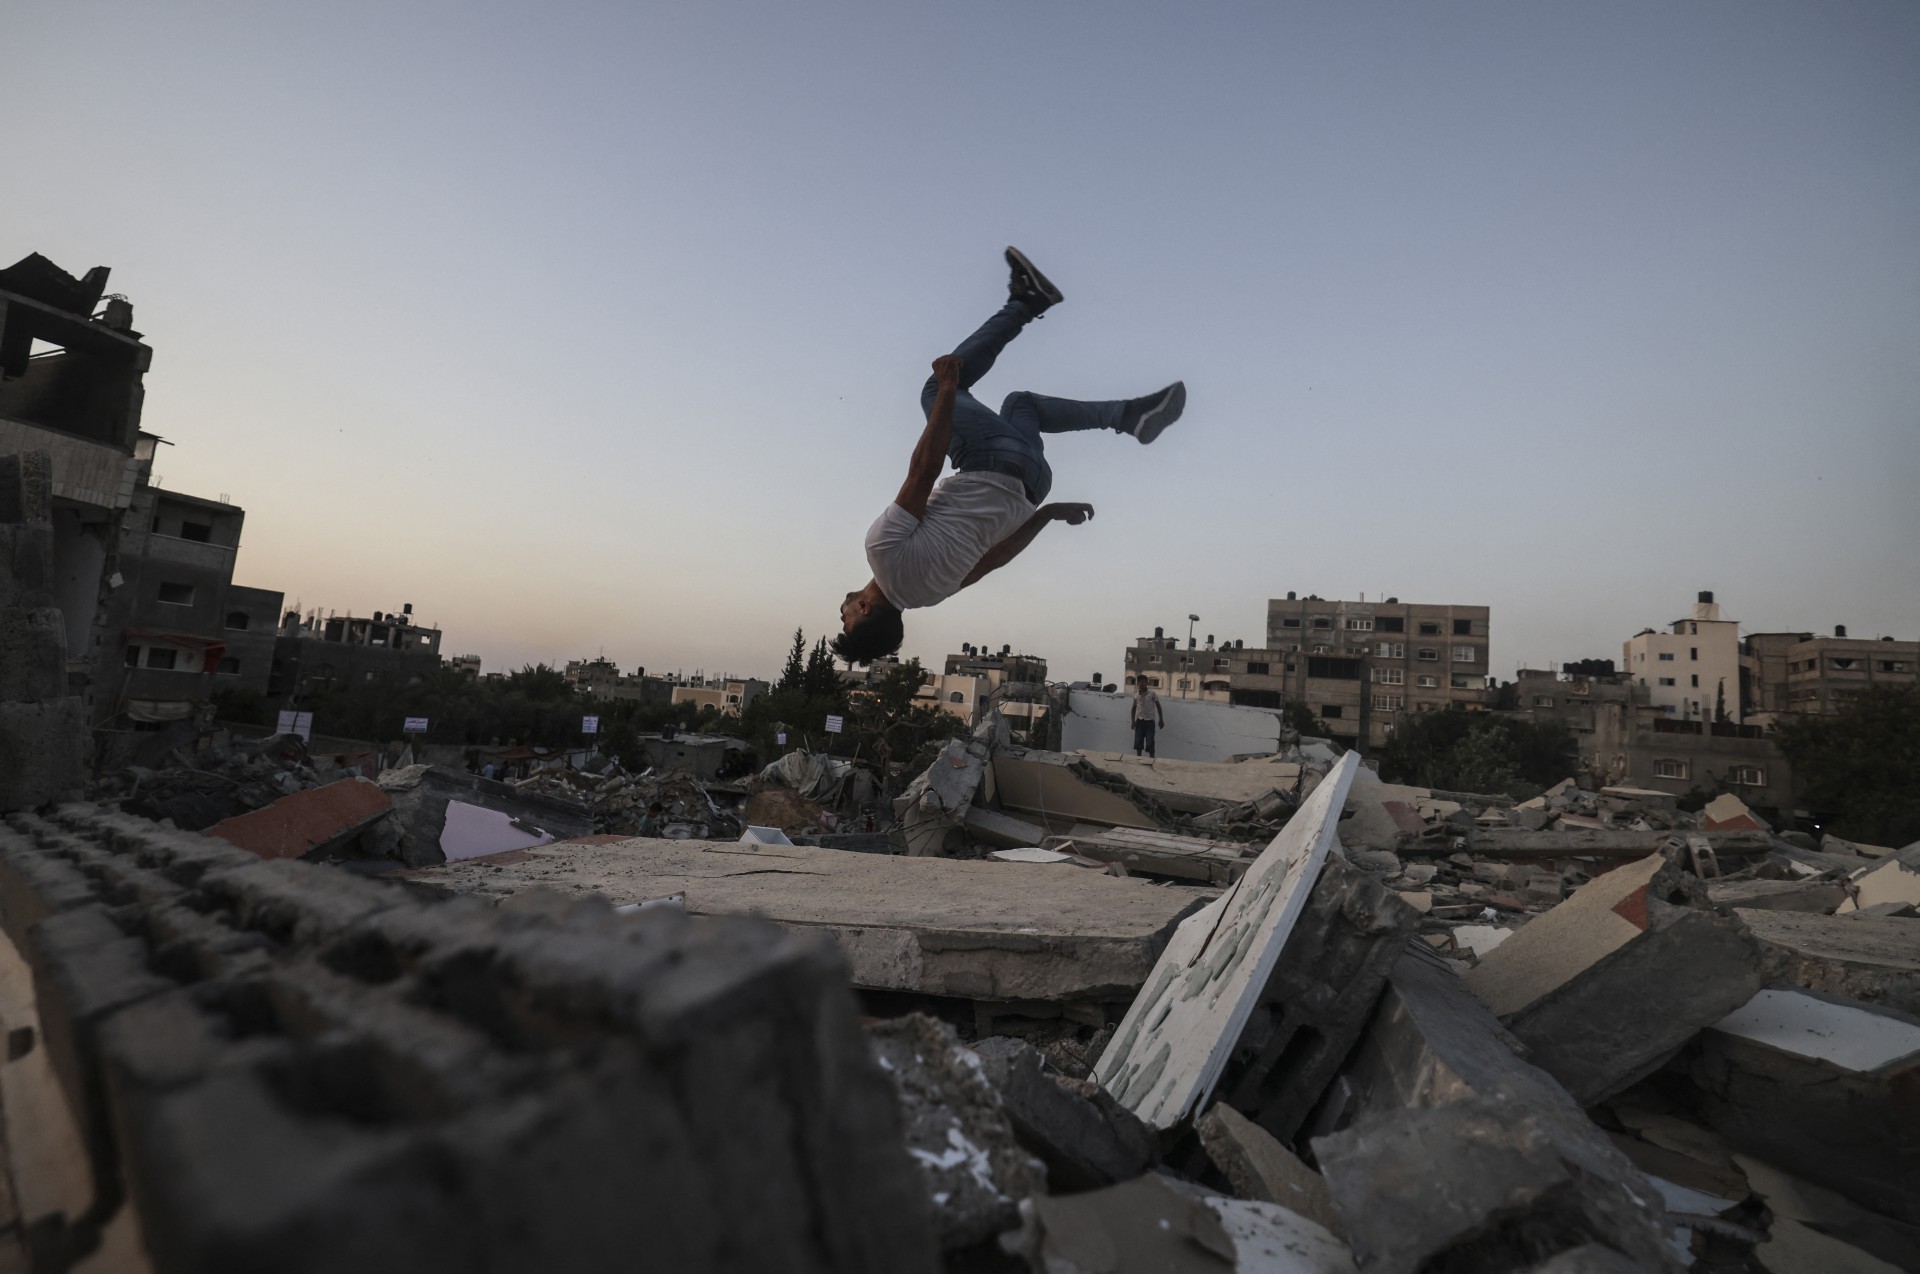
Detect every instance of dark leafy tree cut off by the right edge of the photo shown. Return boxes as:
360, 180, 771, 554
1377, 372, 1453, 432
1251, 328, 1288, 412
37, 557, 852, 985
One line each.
1776, 685, 1920, 846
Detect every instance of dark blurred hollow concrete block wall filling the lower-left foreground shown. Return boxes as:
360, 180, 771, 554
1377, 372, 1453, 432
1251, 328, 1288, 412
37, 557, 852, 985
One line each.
0, 806, 935, 1274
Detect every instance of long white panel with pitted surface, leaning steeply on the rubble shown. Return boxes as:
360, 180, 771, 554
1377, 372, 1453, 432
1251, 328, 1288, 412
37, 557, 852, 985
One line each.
1094, 752, 1359, 1128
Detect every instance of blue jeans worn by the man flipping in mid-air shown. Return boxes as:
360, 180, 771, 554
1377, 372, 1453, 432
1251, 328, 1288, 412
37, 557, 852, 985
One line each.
920, 301, 1127, 505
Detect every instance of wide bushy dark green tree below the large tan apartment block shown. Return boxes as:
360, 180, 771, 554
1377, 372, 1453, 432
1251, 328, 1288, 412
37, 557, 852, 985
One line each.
1379, 708, 1578, 800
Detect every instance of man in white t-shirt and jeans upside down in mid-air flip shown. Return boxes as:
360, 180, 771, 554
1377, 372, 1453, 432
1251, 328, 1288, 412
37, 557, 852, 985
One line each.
833, 248, 1187, 664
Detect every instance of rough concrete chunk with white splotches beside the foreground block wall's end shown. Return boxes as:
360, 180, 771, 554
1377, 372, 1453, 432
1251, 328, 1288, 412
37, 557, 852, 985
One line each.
868, 1013, 1046, 1251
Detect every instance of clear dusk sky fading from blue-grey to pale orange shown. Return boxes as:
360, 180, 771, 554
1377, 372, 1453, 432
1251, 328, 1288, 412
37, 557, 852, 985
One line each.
0, 0, 1920, 679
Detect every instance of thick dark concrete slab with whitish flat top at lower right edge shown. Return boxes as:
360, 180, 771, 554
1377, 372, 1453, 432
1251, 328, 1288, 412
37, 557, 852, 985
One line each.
1688, 988, 1920, 1224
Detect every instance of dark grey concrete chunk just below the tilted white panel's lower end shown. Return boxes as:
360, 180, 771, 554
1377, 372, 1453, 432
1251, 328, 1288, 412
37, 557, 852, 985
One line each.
973, 1036, 1160, 1193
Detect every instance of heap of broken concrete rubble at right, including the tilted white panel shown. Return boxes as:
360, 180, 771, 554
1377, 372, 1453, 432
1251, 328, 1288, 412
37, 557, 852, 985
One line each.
870, 752, 1920, 1274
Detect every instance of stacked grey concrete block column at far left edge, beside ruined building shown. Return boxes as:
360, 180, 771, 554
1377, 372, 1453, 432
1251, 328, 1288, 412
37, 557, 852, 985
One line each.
0, 451, 86, 814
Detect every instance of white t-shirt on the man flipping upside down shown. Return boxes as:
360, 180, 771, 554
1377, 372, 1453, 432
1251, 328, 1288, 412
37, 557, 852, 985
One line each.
866, 474, 1035, 610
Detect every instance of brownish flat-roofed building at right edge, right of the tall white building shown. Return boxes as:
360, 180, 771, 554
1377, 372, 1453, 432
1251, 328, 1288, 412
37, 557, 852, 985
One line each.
1740, 625, 1920, 723
